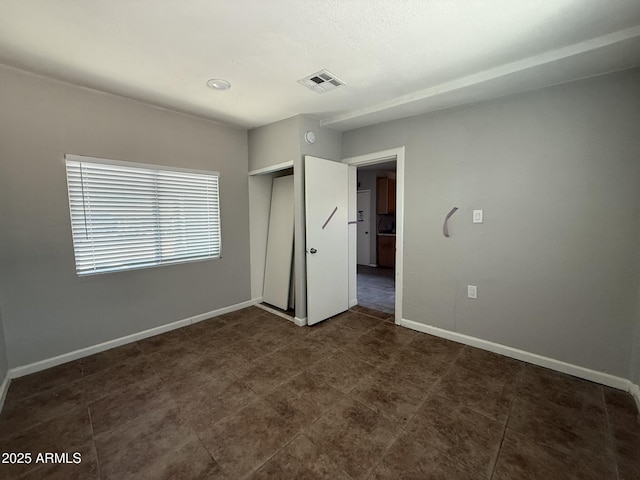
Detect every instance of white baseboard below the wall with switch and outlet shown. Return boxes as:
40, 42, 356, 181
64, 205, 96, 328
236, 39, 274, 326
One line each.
400, 318, 640, 392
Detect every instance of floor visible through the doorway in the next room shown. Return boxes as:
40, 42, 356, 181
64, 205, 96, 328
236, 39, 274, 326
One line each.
356, 265, 396, 313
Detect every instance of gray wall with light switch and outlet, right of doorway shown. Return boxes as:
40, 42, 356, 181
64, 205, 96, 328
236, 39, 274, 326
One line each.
343, 69, 640, 378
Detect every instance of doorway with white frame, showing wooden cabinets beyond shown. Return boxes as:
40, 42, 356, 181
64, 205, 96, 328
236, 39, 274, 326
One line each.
343, 147, 404, 324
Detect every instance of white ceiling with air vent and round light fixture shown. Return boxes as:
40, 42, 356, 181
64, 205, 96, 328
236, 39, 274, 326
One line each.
0, 0, 640, 130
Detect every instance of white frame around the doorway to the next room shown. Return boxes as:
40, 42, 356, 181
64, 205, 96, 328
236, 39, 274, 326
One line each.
342, 146, 404, 325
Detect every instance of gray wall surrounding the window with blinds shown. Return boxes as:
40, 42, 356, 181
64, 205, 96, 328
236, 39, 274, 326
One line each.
0, 67, 250, 367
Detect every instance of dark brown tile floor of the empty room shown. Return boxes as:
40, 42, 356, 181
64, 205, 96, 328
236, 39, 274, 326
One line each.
0, 307, 640, 480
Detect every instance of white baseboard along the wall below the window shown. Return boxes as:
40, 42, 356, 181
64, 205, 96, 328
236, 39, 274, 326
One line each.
7, 300, 254, 378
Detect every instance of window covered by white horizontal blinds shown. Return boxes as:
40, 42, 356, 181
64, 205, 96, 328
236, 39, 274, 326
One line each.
65, 155, 221, 276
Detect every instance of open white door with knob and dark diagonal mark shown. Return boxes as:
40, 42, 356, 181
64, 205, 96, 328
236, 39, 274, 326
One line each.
304, 156, 349, 325
